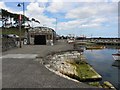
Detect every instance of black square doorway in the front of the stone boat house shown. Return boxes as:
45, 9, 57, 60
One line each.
34, 35, 46, 45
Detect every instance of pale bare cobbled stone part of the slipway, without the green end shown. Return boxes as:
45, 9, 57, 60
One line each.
46, 51, 82, 81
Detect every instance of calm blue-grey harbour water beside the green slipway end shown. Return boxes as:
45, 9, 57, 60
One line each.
84, 49, 120, 89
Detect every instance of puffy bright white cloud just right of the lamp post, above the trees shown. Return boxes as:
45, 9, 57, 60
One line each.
26, 2, 55, 28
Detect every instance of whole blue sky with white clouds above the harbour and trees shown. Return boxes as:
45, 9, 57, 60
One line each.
0, 0, 119, 37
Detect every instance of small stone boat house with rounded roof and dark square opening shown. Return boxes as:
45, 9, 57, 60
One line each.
28, 27, 56, 45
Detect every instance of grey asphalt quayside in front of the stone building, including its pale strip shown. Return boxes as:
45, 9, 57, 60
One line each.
2, 41, 95, 88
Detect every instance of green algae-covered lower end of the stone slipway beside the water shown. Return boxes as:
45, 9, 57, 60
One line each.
67, 61, 101, 81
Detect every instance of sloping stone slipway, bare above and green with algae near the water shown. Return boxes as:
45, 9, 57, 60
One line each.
45, 51, 116, 88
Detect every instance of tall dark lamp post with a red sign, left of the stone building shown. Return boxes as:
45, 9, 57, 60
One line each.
17, 2, 25, 48
